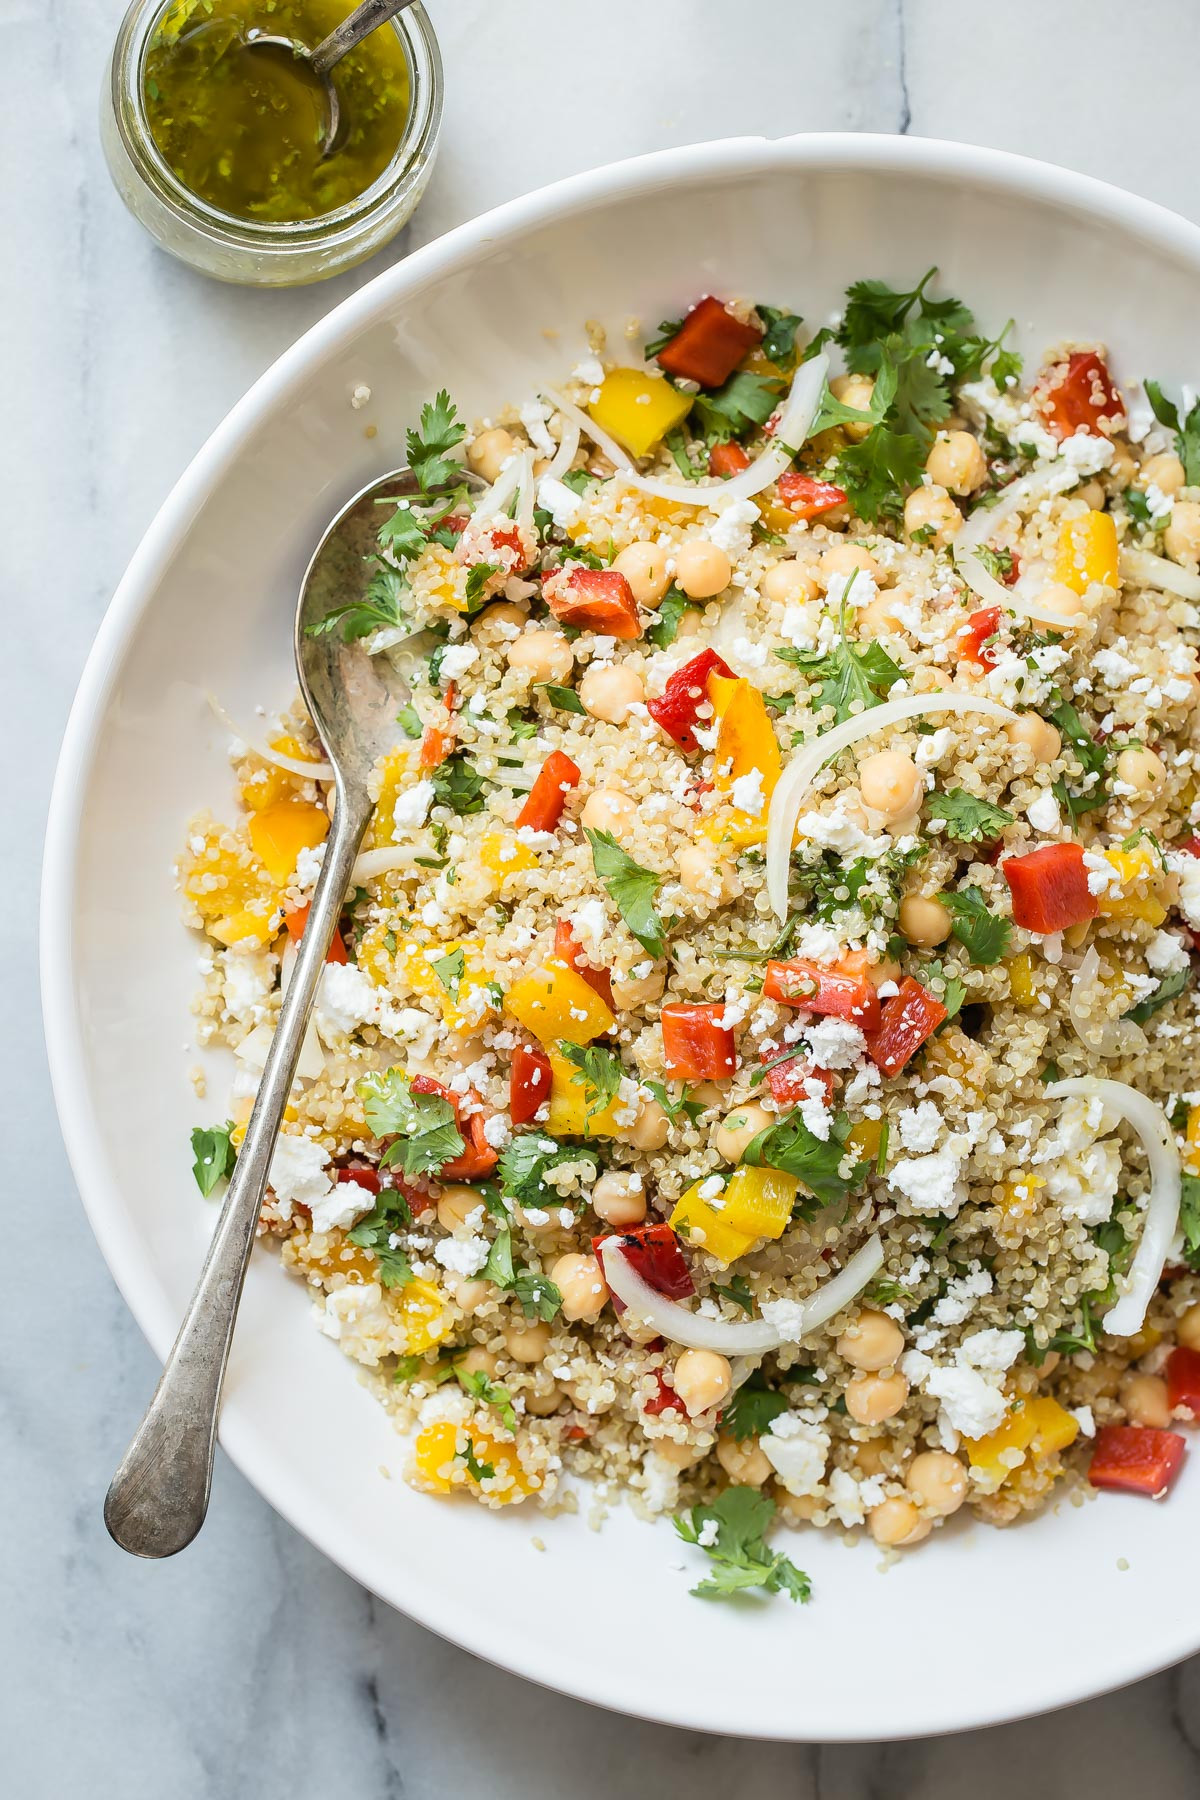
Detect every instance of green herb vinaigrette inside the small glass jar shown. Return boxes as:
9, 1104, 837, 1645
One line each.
142, 0, 410, 223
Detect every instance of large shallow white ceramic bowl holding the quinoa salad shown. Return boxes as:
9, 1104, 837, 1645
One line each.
43, 137, 1200, 1741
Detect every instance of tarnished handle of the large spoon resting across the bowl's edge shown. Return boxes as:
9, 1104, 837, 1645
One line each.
104, 781, 371, 1557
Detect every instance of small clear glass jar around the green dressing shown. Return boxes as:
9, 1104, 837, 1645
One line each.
101, 0, 443, 288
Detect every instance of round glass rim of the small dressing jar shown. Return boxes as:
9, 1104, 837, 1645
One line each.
110, 0, 443, 256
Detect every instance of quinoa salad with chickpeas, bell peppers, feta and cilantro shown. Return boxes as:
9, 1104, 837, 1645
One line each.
178, 270, 1200, 1600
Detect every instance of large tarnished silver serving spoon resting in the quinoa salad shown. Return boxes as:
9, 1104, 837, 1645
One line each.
104, 470, 484, 1557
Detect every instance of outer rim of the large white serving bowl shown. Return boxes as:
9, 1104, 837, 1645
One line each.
40, 131, 1200, 1742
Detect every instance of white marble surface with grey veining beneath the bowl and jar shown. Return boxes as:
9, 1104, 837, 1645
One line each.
0, 0, 1200, 1800
